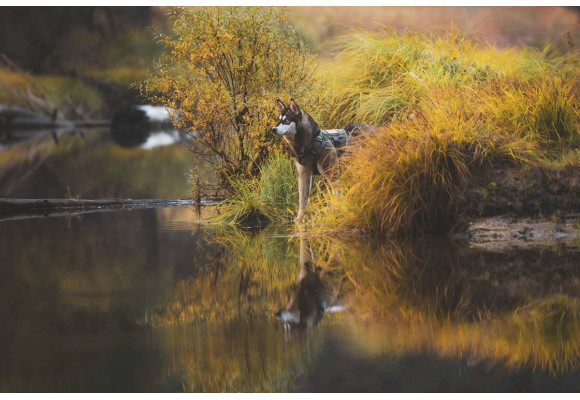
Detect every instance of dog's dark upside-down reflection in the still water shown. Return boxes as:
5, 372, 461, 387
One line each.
276, 238, 343, 331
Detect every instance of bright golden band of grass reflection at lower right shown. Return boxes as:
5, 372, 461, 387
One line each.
344, 296, 580, 375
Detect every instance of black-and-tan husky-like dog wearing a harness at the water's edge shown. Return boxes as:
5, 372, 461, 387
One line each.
272, 99, 369, 223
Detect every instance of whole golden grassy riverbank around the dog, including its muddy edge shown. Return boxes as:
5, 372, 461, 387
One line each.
218, 29, 580, 238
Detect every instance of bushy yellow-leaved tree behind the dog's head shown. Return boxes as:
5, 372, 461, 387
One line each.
143, 7, 322, 194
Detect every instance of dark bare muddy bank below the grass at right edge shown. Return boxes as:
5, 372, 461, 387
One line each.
451, 165, 580, 250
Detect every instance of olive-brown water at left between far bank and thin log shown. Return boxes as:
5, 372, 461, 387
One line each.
0, 130, 196, 199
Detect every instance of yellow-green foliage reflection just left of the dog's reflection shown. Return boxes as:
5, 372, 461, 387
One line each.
150, 229, 299, 325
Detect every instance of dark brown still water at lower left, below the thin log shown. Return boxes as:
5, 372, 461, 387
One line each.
0, 210, 210, 392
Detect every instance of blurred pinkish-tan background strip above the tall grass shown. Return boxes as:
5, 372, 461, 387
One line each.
289, 6, 580, 49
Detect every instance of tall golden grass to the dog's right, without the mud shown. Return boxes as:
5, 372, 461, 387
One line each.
311, 29, 580, 235
